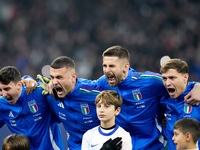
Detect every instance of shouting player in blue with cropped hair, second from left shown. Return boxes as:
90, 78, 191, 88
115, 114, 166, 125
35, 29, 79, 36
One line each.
41, 56, 101, 150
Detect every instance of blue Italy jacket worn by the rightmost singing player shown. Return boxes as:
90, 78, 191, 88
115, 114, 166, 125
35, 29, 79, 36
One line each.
160, 82, 200, 150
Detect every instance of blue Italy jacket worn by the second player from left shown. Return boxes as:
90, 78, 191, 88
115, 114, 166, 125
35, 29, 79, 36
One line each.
49, 78, 101, 150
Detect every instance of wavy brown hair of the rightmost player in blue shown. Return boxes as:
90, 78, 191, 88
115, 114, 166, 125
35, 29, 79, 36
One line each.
160, 59, 189, 74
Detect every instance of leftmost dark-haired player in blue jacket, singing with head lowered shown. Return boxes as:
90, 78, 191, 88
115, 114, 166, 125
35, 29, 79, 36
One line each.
0, 66, 64, 150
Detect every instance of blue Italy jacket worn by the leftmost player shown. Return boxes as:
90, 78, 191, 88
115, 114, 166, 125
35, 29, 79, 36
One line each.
0, 87, 64, 150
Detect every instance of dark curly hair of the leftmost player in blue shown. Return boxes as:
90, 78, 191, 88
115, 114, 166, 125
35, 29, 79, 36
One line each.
0, 66, 21, 85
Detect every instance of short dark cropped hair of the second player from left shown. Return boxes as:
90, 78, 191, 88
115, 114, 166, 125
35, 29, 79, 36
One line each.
51, 56, 75, 69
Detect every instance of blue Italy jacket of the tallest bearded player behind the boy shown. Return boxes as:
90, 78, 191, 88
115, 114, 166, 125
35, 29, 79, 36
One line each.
97, 68, 167, 150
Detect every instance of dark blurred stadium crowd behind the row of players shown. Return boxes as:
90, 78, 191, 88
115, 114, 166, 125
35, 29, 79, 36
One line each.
0, 0, 200, 149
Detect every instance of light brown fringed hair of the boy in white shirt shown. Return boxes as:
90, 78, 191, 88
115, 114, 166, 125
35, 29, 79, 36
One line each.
95, 90, 123, 109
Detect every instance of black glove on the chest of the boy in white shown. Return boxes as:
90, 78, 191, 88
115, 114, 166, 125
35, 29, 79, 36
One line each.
100, 137, 122, 150
